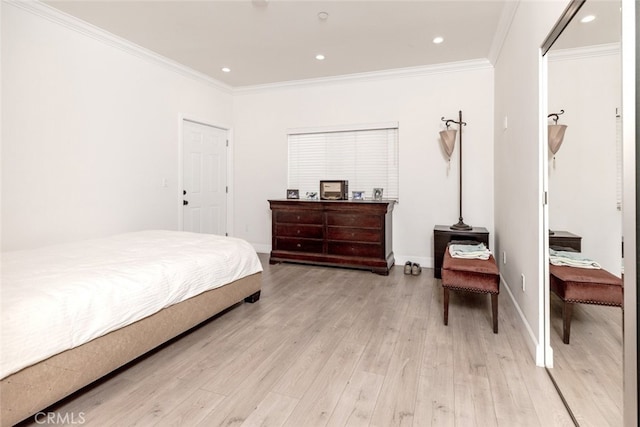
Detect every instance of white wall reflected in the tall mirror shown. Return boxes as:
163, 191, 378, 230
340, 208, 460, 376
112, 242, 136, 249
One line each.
548, 46, 622, 276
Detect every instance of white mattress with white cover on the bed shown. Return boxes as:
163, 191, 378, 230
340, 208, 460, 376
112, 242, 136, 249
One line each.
0, 231, 262, 379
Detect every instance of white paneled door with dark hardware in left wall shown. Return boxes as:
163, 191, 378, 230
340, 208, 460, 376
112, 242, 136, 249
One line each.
182, 120, 228, 235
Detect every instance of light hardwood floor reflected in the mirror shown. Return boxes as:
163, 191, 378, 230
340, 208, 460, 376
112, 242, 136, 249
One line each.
550, 295, 623, 427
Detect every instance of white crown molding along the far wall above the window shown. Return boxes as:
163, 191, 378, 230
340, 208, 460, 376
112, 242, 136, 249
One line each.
233, 59, 493, 94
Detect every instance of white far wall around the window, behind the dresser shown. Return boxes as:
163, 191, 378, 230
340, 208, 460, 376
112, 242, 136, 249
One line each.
234, 67, 493, 266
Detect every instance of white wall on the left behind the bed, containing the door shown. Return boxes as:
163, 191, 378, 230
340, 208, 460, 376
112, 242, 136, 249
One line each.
1, 2, 232, 250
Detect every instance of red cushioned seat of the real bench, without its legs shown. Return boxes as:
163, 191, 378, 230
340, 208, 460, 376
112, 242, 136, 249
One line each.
442, 250, 500, 294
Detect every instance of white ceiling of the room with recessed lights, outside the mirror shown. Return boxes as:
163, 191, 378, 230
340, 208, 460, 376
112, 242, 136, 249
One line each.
46, 0, 620, 87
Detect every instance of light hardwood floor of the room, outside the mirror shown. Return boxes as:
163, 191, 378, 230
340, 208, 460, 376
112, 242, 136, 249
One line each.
20, 255, 573, 427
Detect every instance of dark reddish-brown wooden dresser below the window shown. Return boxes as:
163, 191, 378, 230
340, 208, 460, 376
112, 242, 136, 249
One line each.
269, 200, 395, 275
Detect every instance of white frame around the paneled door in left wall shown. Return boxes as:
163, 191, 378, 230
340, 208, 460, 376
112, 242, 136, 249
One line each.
176, 114, 234, 236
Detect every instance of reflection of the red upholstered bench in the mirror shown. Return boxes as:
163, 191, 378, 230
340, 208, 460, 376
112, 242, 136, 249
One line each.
549, 264, 622, 344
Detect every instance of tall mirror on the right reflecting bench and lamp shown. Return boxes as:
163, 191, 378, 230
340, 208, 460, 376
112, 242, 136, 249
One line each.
546, 0, 624, 426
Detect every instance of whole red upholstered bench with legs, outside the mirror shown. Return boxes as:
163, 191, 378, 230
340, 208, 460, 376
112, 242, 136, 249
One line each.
442, 248, 500, 334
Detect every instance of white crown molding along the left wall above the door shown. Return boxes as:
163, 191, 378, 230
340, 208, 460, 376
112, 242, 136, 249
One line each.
2, 0, 233, 94
